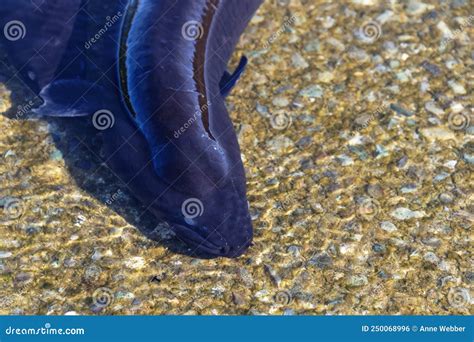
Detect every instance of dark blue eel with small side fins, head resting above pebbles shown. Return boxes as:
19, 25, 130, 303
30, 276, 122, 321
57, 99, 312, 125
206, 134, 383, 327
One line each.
0, 0, 263, 258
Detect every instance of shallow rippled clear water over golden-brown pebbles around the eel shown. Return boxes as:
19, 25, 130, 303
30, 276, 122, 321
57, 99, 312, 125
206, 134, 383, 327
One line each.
0, 0, 474, 315
